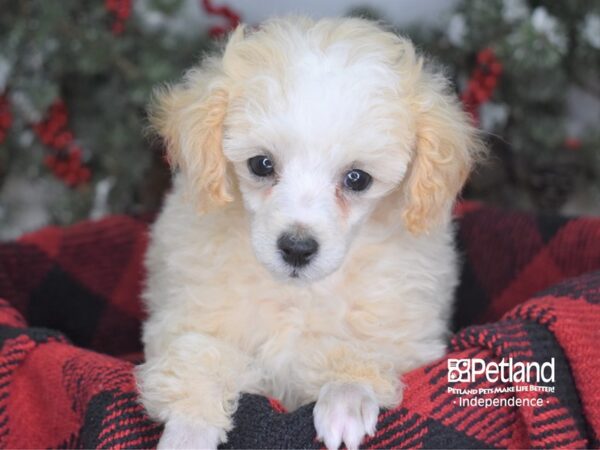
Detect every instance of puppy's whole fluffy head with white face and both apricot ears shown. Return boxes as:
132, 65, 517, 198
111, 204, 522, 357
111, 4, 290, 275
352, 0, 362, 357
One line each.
151, 18, 481, 281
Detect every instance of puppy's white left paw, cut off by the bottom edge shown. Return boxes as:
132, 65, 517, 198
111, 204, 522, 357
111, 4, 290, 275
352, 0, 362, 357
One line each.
157, 419, 226, 450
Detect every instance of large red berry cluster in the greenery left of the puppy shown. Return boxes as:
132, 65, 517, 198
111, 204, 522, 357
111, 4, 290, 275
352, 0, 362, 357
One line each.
33, 100, 91, 187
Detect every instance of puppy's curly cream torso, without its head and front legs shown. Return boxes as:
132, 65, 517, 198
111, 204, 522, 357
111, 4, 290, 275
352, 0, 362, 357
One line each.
144, 176, 456, 409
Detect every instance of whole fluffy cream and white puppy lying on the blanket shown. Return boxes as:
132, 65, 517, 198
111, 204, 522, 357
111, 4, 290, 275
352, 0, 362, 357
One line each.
137, 17, 482, 449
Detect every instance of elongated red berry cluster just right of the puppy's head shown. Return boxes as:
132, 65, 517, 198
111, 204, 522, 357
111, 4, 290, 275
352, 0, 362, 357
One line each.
461, 48, 502, 121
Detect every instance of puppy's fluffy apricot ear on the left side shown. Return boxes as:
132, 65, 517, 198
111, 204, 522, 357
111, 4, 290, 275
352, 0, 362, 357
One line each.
149, 59, 233, 210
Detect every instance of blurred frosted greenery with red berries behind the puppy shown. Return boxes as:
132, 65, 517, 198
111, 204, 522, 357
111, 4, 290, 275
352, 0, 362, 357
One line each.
0, 0, 600, 238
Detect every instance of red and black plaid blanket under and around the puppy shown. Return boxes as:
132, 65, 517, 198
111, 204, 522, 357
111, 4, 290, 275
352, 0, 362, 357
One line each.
0, 203, 600, 448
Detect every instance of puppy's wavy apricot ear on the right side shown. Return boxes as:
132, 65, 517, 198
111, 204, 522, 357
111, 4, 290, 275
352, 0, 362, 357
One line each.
403, 71, 484, 234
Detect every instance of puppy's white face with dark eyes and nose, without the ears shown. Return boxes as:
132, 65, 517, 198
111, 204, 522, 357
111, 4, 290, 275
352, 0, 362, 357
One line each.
223, 56, 414, 281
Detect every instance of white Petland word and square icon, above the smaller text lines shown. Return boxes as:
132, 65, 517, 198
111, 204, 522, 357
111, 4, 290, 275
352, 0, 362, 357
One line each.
448, 358, 554, 383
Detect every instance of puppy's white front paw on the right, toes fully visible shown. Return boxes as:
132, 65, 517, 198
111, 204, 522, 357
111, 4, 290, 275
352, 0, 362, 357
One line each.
313, 383, 379, 450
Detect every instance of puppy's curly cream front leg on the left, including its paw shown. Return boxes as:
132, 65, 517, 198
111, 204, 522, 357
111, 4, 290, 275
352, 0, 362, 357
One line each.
136, 333, 250, 449
